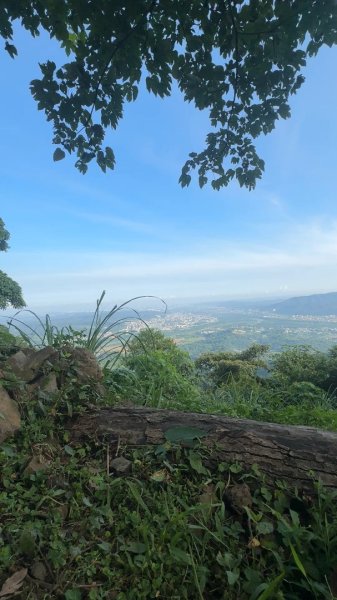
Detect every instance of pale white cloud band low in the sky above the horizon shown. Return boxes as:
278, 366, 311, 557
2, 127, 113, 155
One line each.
2, 222, 337, 310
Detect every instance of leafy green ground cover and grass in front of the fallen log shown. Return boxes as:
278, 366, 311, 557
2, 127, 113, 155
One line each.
0, 372, 337, 600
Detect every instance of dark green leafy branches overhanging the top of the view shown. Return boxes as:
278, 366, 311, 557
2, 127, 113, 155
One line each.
0, 0, 337, 189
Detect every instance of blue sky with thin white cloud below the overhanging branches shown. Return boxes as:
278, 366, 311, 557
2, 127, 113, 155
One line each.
0, 29, 337, 312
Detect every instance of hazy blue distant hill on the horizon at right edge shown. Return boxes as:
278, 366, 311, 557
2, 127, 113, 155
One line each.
269, 292, 337, 316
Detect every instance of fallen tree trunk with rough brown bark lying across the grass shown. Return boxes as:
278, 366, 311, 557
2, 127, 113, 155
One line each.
70, 407, 337, 489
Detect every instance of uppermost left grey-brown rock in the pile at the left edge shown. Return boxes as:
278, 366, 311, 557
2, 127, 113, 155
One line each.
3, 346, 58, 383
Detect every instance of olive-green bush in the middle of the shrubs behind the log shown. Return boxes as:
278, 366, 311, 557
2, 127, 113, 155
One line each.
195, 344, 269, 387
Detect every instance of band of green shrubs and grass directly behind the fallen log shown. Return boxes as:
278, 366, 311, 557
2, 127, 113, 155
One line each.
105, 328, 337, 431
